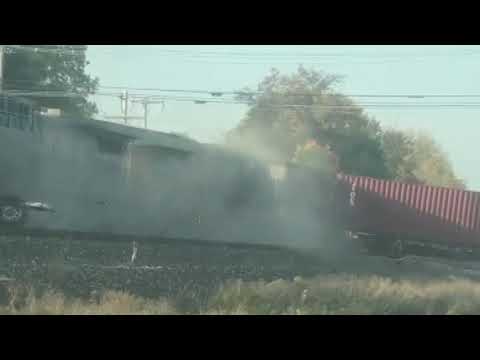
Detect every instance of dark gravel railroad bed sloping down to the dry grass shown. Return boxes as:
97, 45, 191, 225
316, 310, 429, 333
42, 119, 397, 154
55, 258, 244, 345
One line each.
0, 229, 328, 301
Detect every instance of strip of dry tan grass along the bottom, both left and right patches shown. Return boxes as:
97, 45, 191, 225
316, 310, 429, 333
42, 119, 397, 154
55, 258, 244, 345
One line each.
0, 275, 480, 315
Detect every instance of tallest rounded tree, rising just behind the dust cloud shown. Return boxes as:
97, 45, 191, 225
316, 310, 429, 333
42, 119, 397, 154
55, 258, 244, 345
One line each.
227, 66, 388, 177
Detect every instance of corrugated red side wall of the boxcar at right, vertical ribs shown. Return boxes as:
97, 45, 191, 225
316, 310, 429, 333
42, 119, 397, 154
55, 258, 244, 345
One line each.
340, 175, 480, 243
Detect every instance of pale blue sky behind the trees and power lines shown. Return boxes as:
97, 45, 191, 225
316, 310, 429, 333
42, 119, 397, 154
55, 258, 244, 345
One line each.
88, 45, 480, 191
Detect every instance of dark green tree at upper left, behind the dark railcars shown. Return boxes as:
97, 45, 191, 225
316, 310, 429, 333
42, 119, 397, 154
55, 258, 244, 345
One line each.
4, 45, 98, 117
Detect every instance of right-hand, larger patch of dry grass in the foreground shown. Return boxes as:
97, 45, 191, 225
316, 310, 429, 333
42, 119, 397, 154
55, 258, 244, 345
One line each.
209, 275, 480, 315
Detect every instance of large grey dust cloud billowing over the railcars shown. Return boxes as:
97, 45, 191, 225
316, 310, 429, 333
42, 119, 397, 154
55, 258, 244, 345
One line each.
0, 122, 356, 260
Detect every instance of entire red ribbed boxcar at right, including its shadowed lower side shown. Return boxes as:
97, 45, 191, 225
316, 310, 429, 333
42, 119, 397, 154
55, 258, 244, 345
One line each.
339, 175, 480, 253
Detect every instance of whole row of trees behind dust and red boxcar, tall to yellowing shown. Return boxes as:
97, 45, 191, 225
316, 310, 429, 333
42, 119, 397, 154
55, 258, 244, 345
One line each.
227, 66, 464, 187
